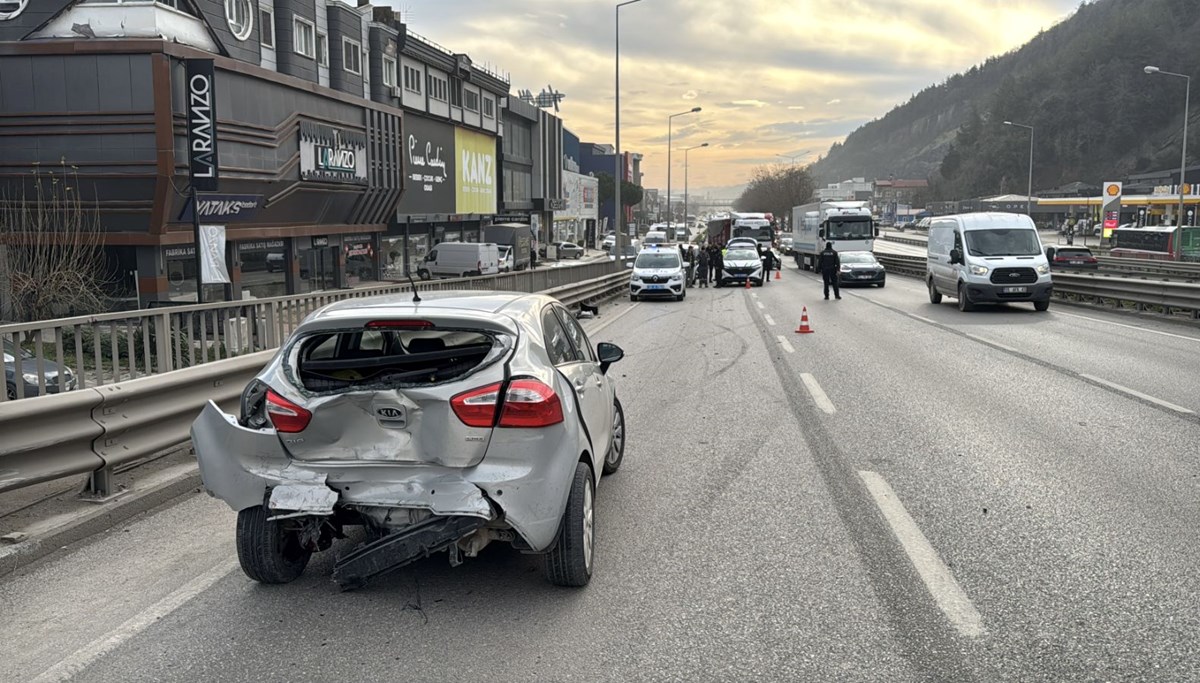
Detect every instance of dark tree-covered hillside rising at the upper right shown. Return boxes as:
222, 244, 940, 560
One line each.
811, 0, 1200, 197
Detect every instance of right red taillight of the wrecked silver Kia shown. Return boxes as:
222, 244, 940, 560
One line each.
450, 379, 563, 429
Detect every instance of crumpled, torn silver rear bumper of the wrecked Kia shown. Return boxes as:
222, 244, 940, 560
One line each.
192, 401, 578, 551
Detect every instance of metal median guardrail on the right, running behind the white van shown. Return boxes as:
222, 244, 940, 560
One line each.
875, 253, 1200, 319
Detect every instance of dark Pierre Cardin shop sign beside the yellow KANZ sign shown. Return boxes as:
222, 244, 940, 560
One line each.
397, 116, 456, 215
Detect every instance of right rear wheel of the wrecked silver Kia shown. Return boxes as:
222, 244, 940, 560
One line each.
545, 462, 595, 587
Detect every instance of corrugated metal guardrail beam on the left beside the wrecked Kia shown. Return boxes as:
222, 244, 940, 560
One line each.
0, 267, 629, 499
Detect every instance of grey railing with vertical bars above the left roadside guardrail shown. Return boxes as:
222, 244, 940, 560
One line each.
0, 259, 618, 402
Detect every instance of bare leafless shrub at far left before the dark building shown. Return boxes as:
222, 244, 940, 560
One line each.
0, 161, 106, 320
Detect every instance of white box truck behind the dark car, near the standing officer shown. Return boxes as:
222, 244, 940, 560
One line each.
792, 202, 880, 270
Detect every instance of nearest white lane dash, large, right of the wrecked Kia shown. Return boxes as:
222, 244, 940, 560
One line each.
858, 469, 984, 637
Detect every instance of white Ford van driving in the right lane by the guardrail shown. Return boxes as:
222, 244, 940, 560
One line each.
925, 214, 1054, 311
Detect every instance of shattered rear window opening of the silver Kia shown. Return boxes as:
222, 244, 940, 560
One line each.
293, 329, 506, 391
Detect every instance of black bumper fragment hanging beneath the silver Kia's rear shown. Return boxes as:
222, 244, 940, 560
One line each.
334, 517, 485, 591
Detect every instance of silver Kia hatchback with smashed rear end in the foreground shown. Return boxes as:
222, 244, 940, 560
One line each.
192, 292, 625, 588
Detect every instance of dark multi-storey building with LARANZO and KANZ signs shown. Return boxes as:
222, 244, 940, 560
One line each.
0, 0, 509, 304
